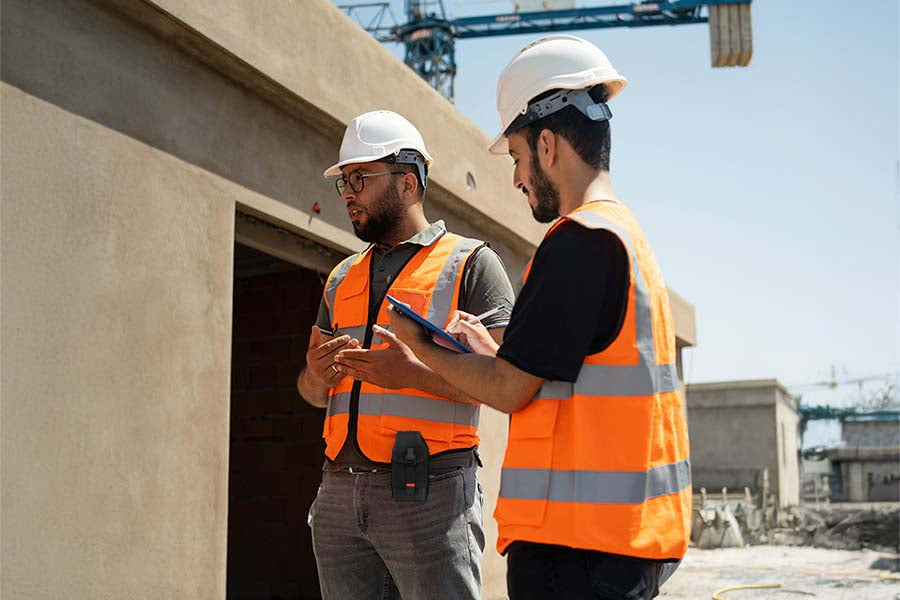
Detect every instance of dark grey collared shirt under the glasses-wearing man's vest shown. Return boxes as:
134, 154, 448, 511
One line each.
316, 221, 515, 467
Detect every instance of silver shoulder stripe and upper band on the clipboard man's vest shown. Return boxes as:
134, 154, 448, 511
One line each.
535, 211, 679, 399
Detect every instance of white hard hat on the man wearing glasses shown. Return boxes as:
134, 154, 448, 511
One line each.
324, 110, 432, 186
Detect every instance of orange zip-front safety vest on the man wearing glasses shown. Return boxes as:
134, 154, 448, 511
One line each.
323, 233, 483, 462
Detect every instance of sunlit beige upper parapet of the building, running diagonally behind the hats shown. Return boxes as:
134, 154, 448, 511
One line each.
107, 0, 546, 254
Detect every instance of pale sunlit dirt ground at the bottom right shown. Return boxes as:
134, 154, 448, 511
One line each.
658, 546, 900, 600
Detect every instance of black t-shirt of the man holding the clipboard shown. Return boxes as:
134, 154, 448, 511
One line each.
497, 221, 630, 382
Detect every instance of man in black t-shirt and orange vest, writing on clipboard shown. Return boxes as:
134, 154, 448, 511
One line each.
390, 35, 691, 600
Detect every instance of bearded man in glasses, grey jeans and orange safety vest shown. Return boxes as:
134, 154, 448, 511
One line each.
297, 110, 513, 600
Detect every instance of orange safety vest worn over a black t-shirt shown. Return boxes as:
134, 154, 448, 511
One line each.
494, 201, 691, 559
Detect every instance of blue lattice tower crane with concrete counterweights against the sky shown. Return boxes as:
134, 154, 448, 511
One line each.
340, 0, 753, 102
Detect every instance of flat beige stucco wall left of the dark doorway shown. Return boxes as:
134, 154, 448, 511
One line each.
0, 83, 234, 599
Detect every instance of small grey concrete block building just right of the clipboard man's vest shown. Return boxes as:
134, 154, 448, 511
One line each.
686, 379, 800, 507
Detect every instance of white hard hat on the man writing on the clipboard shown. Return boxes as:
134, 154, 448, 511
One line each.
488, 35, 628, 154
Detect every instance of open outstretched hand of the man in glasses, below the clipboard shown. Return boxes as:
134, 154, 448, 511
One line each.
334, 325, 427, 389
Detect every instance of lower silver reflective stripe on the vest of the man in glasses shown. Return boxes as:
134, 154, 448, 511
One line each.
328, 392, 480, 427
